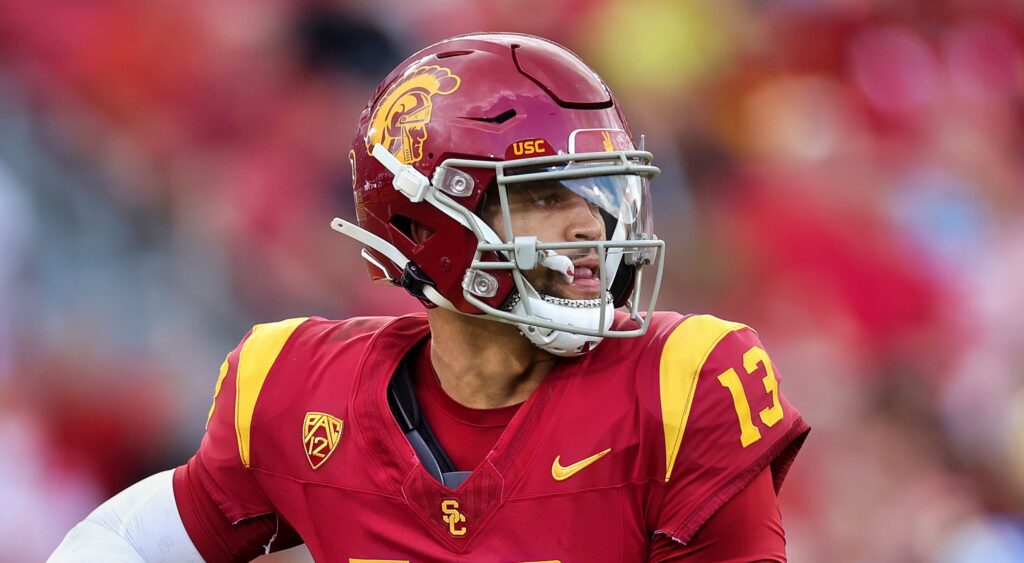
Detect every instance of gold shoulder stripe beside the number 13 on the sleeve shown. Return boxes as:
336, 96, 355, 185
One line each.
659, 314, 746, 482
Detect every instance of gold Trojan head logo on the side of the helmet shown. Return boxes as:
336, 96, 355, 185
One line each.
366, 67, 462, 164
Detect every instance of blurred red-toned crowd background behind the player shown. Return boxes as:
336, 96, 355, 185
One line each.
0, 0, 1024, 563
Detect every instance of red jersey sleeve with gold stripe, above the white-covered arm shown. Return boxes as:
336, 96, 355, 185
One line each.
189, 318, 306, 523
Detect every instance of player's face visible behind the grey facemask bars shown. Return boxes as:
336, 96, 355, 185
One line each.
481, 181, 606, 299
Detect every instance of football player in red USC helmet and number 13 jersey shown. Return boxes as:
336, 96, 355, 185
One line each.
52, 34, 808, 563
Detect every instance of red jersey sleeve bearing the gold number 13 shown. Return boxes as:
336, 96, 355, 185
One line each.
655, 315, 810, 543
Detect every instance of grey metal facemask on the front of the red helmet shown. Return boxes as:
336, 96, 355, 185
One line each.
434, 150, 664, 356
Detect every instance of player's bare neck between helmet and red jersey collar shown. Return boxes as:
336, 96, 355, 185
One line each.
427, 308, 556, 408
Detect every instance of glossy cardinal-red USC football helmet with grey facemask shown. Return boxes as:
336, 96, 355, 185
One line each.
333, 34, 664, 355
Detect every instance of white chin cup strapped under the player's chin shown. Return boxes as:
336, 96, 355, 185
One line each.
508, 294, 615, 357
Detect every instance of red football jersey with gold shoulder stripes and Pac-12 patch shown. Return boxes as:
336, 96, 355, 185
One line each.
184, 313, 809, 563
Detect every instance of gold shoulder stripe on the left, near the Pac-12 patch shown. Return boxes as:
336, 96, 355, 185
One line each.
234, 316, 309, 467
